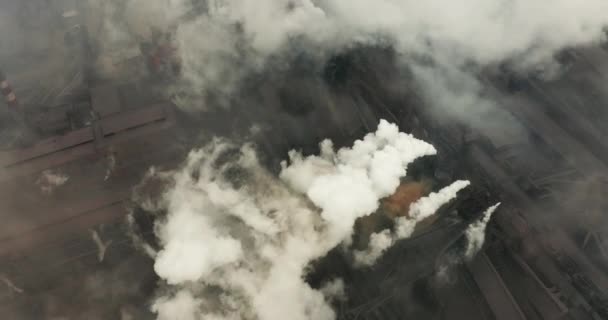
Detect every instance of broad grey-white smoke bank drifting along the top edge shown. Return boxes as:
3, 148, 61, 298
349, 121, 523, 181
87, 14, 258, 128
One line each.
81, 0, 608, 136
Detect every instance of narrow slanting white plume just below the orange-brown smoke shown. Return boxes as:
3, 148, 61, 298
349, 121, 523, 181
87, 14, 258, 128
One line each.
354, 180, 470, 266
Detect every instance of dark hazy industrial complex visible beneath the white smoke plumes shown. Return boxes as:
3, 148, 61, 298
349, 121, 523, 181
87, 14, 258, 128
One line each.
0, 0, 608, 320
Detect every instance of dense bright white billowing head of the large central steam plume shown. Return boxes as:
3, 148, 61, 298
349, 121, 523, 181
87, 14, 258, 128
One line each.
281, 120, 436, 241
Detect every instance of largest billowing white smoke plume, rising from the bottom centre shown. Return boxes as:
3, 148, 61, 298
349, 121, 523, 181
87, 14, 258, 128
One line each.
146, 121, 456, 320
